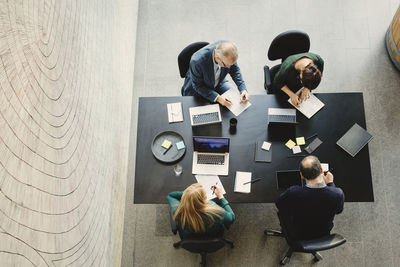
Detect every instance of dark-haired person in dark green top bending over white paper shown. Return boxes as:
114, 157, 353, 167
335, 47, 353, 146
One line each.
273, 53, 324, 106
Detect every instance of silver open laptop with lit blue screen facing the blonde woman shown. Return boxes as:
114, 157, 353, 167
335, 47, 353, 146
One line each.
192, 136, 229, 175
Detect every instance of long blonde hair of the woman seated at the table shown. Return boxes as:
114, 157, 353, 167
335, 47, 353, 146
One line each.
174, 183, 224, 233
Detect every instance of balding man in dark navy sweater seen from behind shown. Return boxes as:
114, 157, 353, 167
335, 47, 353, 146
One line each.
276, 156, 344, 240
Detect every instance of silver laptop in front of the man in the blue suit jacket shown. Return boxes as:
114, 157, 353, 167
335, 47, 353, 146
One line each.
189, 104, 222, 126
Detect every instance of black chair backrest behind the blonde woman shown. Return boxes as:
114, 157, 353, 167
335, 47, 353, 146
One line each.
181, 238, 225, 253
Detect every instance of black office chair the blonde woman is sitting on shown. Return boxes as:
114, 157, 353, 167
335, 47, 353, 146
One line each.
169, 205, 234, 266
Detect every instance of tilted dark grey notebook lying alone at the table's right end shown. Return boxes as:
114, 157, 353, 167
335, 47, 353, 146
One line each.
336, 123, 373, 157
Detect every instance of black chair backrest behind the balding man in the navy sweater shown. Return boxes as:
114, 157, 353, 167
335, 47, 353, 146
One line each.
294, 234, 346, 253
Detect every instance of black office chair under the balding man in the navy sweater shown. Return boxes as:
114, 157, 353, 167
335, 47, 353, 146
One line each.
264, 229, 346, 265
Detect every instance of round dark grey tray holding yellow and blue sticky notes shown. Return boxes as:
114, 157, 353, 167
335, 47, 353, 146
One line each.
151, 131, 186, 163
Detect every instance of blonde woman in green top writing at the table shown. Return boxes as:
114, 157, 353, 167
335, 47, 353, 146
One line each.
167, 183, 235, 238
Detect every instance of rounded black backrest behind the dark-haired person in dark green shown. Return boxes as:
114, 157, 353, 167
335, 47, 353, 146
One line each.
268, 30, 310, 62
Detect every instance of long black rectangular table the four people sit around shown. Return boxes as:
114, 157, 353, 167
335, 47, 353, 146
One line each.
134, 93, 374, 204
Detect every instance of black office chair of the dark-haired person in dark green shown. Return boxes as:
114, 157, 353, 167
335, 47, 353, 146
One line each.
264, 30, 310, 94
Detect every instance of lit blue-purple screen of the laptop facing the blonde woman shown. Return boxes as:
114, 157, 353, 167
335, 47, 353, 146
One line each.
193, 137, 229, 153
